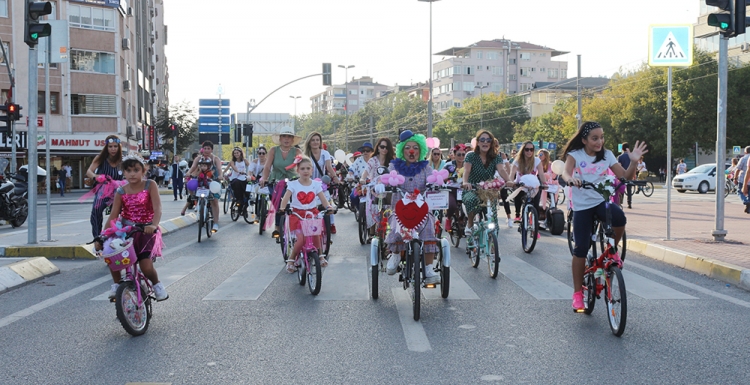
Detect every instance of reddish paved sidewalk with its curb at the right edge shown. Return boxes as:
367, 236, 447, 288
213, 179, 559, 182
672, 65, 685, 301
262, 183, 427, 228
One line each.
625, 189, 750, 290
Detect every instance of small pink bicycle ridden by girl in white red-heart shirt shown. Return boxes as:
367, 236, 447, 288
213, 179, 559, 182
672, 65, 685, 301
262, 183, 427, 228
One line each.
284, 207, 331, 295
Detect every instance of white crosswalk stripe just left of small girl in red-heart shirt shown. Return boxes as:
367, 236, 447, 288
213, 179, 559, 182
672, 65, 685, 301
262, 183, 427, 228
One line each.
203, 249, 284, 301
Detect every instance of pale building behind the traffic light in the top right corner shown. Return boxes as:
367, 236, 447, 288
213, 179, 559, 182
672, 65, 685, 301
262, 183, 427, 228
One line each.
693, 0, 750, 59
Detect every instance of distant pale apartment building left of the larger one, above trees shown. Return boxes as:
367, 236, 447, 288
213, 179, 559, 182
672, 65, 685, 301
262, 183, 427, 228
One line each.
310, 76, 389, 115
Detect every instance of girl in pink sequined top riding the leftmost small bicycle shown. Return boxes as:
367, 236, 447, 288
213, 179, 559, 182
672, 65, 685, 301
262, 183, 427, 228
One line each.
105, 152, 169, 301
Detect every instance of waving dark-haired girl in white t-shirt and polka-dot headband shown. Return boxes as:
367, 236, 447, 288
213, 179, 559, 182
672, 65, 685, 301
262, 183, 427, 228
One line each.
563, 122, 648, 311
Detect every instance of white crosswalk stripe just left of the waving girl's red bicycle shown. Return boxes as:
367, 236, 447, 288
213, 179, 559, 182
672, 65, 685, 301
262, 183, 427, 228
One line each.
500, 254, 573, 300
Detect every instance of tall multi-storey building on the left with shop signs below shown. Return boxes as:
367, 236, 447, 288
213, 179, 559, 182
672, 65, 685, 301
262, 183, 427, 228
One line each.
0, 0, 169, 188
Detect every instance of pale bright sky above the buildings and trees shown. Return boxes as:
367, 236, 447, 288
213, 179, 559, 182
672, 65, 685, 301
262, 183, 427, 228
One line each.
164, 0, 702, 114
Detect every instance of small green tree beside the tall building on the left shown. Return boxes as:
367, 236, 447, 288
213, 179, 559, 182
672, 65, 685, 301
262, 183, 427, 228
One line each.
154, 101, 198, 160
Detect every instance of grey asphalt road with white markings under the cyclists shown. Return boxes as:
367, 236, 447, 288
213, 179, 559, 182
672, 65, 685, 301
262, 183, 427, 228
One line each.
0, 206, 750, 384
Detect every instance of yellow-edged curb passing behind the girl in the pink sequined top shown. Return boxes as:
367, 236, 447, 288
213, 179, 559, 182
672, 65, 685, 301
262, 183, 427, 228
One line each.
0, 213, 198, 260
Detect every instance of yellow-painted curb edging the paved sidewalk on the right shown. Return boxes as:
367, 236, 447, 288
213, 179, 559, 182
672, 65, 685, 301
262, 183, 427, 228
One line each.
628, 239, 750, 291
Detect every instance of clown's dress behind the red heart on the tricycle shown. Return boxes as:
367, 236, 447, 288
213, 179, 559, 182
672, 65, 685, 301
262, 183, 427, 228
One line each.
385, 159, 438, 253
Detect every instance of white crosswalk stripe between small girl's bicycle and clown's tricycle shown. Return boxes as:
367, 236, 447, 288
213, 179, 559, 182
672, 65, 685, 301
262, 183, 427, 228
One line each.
315, 255, 369, 301
